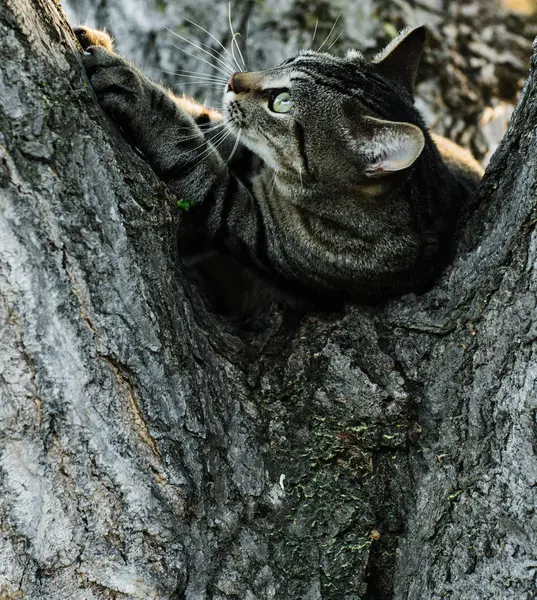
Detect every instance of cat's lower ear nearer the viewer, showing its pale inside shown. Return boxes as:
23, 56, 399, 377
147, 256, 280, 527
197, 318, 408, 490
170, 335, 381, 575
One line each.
355, 117, 425, 177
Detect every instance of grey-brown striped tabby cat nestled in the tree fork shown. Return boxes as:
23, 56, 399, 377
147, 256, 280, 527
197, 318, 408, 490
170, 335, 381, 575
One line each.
75, 27, 482, 302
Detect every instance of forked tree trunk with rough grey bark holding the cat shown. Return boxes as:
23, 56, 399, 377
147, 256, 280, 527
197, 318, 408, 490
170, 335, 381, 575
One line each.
0, 0, 537, 600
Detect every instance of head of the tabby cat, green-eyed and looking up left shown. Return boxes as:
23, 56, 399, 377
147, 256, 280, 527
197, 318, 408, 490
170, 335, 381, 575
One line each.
224, 27, 425, 190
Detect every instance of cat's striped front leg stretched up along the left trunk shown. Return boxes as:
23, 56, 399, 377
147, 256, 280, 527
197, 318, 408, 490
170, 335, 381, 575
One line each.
72, 26, 269, 270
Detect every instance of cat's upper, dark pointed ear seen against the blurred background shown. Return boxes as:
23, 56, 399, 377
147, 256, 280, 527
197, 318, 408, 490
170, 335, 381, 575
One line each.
373, 25, 427, 95
